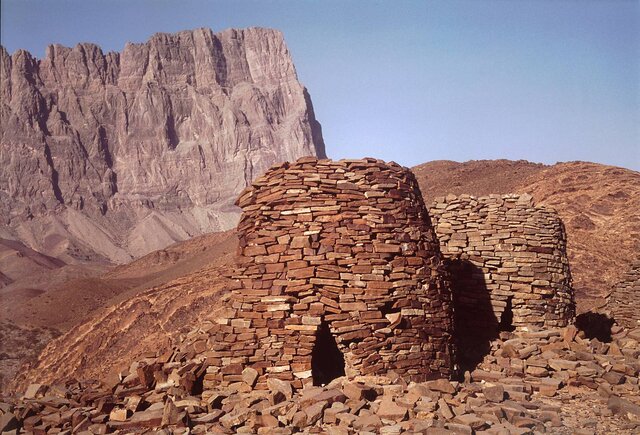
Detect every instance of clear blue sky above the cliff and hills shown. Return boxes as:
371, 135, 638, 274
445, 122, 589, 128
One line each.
1, 0, 640, 170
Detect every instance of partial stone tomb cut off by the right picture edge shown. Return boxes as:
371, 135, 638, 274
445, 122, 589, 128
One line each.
608, 260, 640, 328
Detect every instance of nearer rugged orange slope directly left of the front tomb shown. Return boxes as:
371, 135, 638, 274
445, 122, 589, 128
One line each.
8, 256, 231, 392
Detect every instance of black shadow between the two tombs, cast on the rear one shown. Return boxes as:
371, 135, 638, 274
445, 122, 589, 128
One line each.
445, 259, 500, 374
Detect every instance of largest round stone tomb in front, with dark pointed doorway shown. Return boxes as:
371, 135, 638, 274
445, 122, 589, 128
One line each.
205, 158, 452, 388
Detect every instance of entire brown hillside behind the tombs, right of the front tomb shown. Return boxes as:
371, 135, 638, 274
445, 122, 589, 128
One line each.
413, 160, 640, 312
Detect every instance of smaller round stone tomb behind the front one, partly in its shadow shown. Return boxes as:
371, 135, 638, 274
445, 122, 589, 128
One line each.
429, 195, 575, 331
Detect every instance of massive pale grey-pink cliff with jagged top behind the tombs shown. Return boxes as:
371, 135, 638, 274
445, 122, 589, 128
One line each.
0, 28, 325, 262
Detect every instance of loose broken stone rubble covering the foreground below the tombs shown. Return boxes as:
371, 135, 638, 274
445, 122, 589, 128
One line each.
0, 325, 640, 435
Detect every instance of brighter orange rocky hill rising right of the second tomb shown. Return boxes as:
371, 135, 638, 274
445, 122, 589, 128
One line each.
523, 162, 640, 308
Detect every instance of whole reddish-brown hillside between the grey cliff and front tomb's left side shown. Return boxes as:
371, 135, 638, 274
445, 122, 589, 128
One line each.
0, 231, 237, 390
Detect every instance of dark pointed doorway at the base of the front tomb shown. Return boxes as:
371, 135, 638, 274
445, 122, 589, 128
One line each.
311, 321, 344, 386
